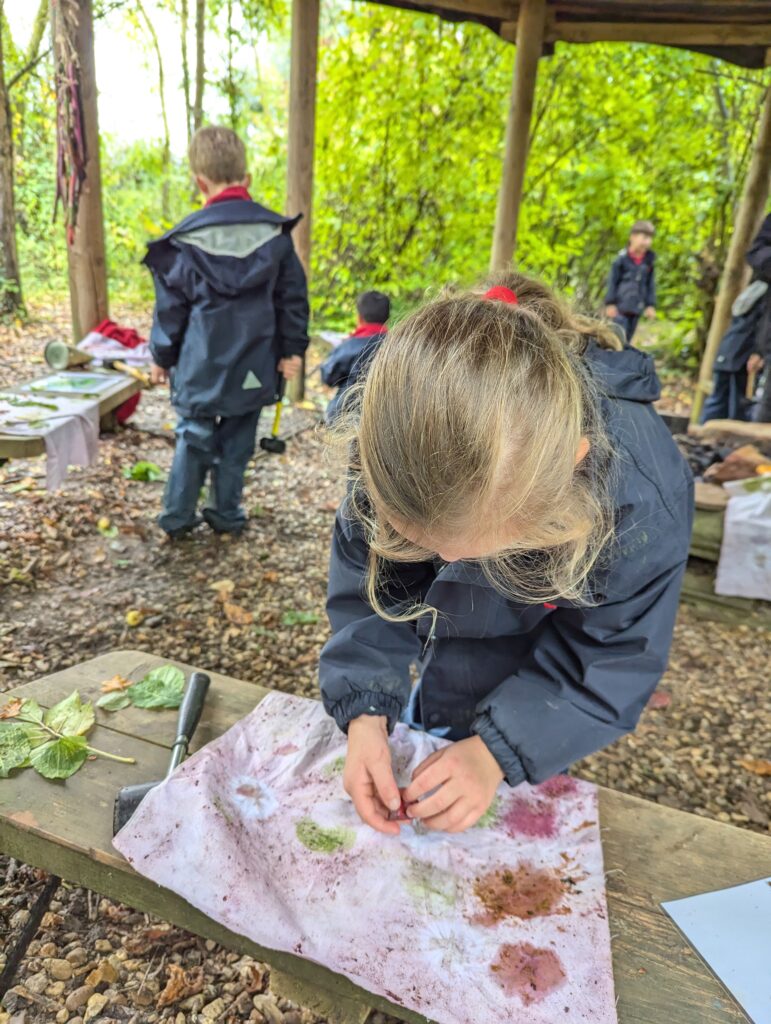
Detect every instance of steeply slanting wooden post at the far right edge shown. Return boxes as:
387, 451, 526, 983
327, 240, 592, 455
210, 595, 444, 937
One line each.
691, 81, 771, 423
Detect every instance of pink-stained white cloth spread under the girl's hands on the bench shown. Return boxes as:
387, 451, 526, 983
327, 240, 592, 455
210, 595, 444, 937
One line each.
115, 693, 616, 1024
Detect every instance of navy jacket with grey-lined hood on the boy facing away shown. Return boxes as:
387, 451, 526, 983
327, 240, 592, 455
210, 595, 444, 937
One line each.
143, 199, 308, 419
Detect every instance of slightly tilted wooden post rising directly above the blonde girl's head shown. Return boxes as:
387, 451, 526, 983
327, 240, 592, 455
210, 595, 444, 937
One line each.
490, 0, 546, 270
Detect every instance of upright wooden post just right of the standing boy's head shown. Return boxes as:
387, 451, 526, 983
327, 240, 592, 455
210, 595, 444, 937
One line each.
287, 0, 319, 400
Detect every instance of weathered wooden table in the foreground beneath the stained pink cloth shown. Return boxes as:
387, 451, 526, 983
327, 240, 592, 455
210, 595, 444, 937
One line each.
0, 651, 771, 1024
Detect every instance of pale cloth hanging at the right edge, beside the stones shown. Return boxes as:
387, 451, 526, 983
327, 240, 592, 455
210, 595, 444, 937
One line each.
715, 474, 771, 601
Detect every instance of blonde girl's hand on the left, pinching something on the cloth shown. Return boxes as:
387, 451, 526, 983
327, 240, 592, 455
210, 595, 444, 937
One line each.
343, 715, 401, 836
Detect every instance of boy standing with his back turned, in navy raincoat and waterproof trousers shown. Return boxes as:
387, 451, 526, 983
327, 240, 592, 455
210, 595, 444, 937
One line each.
144, 127, 308, 538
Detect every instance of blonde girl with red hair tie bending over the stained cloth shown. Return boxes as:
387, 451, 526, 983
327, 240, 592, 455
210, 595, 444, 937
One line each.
320, 275, 693, 833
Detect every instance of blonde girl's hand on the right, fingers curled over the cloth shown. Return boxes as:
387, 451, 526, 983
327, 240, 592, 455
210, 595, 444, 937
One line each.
402, 736, 504, 833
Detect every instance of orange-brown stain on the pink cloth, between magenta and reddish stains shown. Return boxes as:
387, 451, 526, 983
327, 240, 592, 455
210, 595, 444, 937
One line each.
474, 864, 570, 925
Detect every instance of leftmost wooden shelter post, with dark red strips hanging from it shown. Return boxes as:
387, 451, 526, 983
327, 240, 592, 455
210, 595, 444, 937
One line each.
54, 0, 109, 342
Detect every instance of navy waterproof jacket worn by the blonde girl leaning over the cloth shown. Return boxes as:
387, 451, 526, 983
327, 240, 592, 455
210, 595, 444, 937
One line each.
319, 344, 693, 785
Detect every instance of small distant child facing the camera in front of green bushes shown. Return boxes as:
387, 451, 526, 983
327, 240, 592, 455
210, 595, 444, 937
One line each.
605, 220, 656, 343
